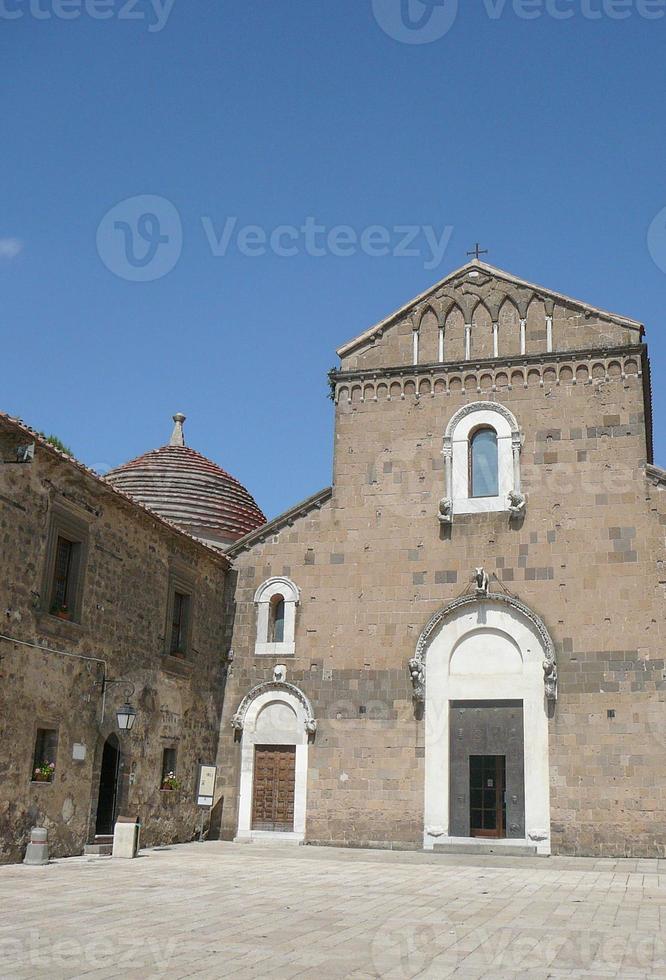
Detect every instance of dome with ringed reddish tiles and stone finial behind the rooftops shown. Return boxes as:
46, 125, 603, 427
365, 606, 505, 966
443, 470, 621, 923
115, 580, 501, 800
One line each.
106, 414, 266, 548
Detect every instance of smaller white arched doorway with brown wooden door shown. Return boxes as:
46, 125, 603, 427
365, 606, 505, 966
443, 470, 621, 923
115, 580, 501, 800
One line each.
233, 680, 317, 841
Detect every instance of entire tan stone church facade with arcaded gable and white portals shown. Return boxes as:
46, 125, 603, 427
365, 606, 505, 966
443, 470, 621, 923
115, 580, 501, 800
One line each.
218, 260, 666, 855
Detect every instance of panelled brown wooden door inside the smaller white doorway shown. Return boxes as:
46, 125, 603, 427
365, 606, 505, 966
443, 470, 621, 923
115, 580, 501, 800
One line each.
252, 745, 296, 832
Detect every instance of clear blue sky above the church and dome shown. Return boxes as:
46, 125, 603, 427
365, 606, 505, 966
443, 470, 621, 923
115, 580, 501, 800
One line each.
0, 0, 666, 516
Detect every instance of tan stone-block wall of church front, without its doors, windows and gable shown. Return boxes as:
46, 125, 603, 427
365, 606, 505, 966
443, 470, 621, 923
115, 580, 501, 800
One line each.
219, 340, 666, 855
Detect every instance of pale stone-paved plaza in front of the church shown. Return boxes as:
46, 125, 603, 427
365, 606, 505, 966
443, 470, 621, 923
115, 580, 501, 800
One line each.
0, 842, 666, 980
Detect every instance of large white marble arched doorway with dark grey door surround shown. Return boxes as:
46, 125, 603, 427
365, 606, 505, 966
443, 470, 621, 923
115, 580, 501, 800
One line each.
415, 593, 557, 854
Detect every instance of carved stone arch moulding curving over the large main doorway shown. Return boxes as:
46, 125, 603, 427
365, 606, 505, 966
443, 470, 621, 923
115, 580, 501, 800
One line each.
409, 592, 557, 701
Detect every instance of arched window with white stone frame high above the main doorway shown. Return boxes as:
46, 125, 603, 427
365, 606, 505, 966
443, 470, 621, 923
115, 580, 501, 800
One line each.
440, 402, 525, 522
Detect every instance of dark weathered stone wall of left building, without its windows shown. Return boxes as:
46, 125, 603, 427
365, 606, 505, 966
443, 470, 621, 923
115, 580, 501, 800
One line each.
0, 423, 228, 862
